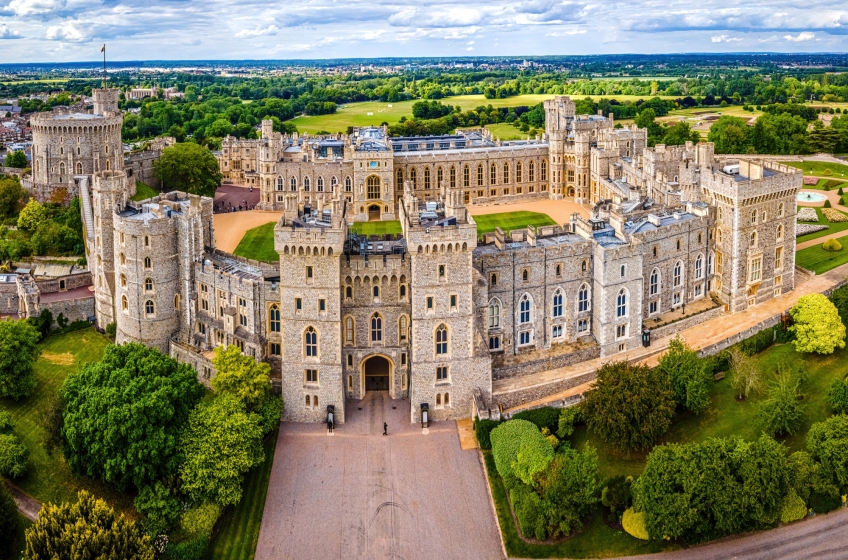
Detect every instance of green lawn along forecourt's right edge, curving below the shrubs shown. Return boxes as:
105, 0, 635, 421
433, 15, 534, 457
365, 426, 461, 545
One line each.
484, 451, 677, 558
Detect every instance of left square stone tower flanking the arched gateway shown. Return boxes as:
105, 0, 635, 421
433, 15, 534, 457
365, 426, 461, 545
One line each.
274, 198, 347, 422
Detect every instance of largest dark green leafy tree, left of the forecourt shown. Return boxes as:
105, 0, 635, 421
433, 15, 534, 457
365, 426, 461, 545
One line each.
60, 343, 204, 488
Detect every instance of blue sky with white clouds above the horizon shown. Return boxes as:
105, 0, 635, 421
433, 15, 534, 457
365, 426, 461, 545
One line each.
0, 0, 848, 62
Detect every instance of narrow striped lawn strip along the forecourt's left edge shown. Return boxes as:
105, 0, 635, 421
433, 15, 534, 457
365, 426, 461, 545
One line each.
210, 432, 278, 560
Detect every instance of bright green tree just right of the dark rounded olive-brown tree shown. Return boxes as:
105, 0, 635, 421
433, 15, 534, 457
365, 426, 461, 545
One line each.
657, 335, 710, 414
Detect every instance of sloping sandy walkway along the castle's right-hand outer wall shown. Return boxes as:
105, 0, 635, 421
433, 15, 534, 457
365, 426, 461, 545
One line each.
492, 264, 848, 412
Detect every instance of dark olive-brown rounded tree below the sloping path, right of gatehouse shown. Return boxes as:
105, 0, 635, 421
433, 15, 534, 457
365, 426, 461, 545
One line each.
583, 362, 675, 453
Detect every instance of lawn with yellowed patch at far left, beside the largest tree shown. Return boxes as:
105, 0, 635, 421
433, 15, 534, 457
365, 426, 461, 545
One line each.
0, 329, 137, 518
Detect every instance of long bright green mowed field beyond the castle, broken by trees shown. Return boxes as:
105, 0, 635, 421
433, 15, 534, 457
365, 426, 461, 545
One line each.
290, 94, 674, 134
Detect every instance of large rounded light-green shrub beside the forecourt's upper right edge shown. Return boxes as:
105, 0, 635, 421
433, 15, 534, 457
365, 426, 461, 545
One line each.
490, 420, 554, 484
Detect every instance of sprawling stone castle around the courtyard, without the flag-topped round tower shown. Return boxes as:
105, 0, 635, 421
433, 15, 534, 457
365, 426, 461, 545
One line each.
39, 93, 801, 422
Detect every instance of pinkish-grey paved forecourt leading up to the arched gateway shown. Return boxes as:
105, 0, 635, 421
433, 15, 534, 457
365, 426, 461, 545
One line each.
256, 391, 503, 560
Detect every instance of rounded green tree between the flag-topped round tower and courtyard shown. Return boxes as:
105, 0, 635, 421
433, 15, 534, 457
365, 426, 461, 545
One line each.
154, 142, 223, 196
